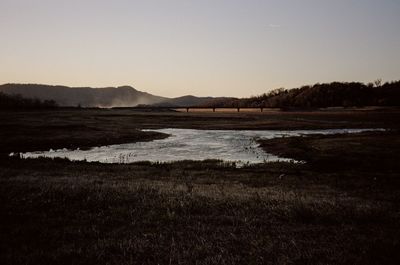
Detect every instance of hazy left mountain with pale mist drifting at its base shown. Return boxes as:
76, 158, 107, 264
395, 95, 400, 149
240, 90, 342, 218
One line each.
0, 84, 169, 108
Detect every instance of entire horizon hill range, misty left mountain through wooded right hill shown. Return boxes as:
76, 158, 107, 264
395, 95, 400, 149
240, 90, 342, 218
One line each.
0, 81, 400, 109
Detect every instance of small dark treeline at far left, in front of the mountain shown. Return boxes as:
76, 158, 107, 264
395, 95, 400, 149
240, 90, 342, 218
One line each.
0, 92, 58, 110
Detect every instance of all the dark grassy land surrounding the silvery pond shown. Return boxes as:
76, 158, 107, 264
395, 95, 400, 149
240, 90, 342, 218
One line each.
0, 109, 400, 264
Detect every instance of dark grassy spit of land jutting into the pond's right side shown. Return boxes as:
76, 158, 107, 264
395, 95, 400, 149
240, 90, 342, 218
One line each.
259, 130, 400, 172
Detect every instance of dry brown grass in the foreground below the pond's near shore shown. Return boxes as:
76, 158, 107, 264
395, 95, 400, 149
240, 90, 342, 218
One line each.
0, 159, 400, 264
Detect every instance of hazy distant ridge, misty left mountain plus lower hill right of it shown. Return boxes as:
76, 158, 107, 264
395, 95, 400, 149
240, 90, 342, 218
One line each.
0, 83, 228, 108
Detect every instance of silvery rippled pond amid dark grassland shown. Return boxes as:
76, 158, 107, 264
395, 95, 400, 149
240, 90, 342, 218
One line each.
21, 129, 381, 166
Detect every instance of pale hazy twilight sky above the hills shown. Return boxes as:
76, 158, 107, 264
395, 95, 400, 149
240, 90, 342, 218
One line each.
0, 0, 400, 97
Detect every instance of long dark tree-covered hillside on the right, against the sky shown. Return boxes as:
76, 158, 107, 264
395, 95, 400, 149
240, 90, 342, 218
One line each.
203, 80, 400, 109
